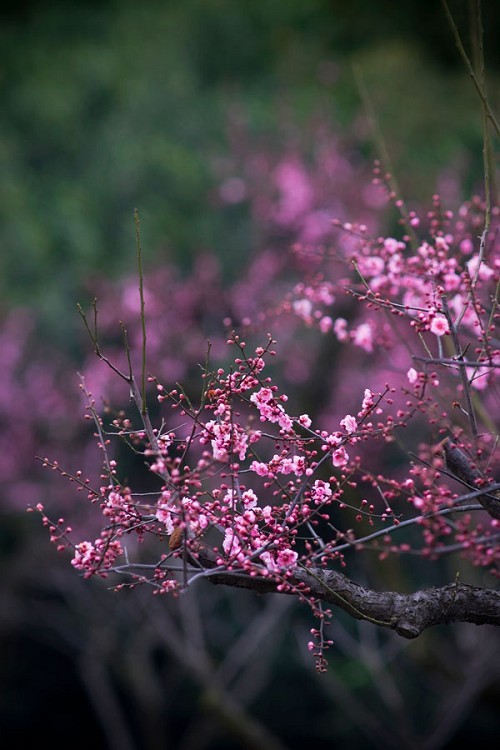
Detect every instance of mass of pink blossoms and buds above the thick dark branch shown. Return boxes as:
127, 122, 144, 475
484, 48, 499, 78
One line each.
33, 160, 500, 649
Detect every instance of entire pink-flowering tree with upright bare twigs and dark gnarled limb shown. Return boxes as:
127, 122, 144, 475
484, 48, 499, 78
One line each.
32, 0, 500, 671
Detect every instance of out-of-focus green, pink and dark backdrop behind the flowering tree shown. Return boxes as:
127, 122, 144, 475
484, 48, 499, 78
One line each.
0, 0, 500, 750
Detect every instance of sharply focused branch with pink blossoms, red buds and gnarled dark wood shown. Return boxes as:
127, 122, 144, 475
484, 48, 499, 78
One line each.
34, 201, 500, 660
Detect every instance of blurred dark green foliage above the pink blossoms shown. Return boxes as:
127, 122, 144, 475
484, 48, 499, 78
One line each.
0, 0, 500, 347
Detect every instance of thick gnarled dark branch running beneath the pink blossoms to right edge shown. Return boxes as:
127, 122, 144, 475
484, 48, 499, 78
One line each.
210, 568, 500, 638
